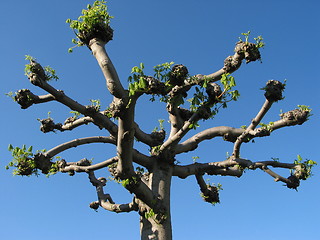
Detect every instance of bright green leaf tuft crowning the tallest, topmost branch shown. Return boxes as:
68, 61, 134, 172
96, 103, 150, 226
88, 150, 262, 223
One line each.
66, 1, 113, 53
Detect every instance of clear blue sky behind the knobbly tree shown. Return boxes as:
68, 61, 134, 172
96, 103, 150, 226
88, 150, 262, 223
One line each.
0, 0, 320, 240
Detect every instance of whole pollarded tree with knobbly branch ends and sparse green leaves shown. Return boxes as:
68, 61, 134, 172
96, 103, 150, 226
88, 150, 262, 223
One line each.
8, 1, 316, 240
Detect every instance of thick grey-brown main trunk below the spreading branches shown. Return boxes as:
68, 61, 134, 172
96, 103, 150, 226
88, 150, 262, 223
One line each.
140, 160, 172, 240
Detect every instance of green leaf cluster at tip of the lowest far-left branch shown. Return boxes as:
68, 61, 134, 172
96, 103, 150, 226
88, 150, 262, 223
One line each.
6, 144, 38, 176
